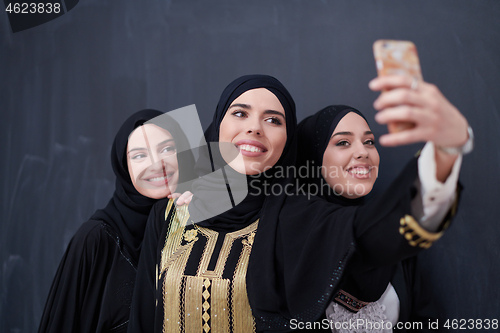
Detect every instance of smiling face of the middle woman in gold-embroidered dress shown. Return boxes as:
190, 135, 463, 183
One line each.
219, 88, 286, 175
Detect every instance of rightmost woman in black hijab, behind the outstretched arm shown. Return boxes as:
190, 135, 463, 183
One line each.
297, 105, 458, 332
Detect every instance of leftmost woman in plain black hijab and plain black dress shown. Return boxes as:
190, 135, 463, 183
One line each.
39, 109, 194, 332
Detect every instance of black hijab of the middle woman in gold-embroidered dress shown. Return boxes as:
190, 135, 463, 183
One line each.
189, 75, 297, 232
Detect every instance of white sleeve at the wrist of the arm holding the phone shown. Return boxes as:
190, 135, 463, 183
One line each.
411, 142, 462, 232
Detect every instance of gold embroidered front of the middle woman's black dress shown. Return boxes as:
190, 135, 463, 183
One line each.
156, 201, 258, 333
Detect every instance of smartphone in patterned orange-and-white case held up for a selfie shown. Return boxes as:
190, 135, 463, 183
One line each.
373, 39, 422, 133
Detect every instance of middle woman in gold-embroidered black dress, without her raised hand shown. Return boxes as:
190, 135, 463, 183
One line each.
129, 75, 465, 332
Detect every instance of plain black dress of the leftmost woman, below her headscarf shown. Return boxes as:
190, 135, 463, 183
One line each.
39, 220, 140, 332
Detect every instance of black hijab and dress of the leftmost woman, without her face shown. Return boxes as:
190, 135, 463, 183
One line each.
39, 110, 194, 333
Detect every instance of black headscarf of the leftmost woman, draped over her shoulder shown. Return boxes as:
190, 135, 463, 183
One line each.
91, 109, 194, 264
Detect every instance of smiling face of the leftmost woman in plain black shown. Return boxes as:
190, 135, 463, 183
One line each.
127, 124, 179, 199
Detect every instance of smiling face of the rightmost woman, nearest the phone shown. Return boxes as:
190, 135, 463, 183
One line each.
321, 112, 380, 199
